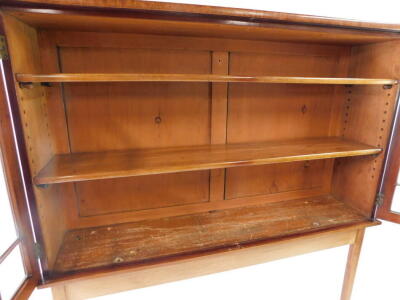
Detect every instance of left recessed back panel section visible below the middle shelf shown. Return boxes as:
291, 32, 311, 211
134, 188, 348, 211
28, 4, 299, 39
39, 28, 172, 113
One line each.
75, 171, 210, 219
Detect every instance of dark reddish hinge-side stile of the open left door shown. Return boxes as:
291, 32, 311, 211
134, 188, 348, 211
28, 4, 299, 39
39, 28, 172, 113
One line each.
0, 17, 46, 279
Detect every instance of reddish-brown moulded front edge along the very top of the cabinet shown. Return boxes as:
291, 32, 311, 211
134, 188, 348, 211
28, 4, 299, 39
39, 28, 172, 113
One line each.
0, 0, 400, 34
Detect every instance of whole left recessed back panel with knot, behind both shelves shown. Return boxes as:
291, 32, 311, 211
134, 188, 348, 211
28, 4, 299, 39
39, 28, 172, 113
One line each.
59, 47, 211, 216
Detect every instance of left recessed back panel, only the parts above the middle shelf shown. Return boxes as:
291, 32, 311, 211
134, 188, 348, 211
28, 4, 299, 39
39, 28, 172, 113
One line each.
59, 48, 211, 152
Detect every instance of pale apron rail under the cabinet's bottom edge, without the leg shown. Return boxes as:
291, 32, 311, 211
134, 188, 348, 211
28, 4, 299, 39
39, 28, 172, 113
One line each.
50, 225, 379, 300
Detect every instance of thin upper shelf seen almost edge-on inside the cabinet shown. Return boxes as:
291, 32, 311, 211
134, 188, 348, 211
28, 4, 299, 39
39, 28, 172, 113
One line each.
16, 73, 397, 85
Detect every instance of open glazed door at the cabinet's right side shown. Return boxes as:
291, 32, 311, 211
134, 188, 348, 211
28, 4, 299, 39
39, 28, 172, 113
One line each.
377, 90, 400, 223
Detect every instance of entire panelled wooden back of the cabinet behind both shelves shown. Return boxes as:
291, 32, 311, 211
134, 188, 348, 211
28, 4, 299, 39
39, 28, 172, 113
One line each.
40, 30, 350, 227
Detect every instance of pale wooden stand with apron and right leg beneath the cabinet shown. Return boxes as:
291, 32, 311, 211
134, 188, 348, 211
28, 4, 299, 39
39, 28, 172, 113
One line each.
52, 222, 376, 300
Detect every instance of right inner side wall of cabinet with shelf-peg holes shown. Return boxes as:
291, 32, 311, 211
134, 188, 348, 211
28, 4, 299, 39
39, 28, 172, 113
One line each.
333, 42, 400, 216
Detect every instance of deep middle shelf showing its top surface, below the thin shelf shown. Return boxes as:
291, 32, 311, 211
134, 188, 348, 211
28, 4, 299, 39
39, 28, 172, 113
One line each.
34, 137, 381, 184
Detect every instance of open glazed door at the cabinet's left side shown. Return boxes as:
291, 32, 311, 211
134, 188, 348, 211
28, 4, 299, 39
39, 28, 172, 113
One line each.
0, 27, 41, 300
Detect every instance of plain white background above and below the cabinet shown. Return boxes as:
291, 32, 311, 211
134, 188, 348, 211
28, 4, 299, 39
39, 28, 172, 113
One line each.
23, 0, 400, 300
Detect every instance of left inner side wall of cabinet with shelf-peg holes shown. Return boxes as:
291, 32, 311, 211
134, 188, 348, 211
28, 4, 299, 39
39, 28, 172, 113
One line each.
4, 16, 67, 268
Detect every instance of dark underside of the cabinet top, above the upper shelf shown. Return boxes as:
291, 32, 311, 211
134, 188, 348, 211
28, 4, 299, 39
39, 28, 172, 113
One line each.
3, 0, 399, 45
